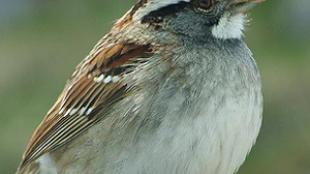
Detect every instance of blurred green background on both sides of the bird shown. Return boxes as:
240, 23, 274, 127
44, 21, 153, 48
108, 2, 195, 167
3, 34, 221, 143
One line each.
0, 0, 310, 174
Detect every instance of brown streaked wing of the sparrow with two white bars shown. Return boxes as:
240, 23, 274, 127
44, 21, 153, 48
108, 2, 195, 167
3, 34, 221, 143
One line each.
21, 40, 151, 166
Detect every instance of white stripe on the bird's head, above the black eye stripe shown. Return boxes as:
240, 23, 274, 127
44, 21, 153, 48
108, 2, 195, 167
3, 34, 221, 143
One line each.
133, 0, 191, 21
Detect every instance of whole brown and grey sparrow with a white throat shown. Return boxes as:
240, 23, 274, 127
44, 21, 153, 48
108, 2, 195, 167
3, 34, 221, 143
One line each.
17, 0, 263, 174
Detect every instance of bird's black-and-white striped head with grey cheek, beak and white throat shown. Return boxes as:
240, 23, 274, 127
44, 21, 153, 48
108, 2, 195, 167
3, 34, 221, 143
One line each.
118, 0, 264, 39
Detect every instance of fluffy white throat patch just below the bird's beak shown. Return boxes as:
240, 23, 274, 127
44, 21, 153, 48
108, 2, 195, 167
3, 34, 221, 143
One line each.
212, 14, 245, 39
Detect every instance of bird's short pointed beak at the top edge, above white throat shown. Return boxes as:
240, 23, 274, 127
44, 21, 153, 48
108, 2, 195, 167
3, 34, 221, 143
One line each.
227, 0, 265, 14
